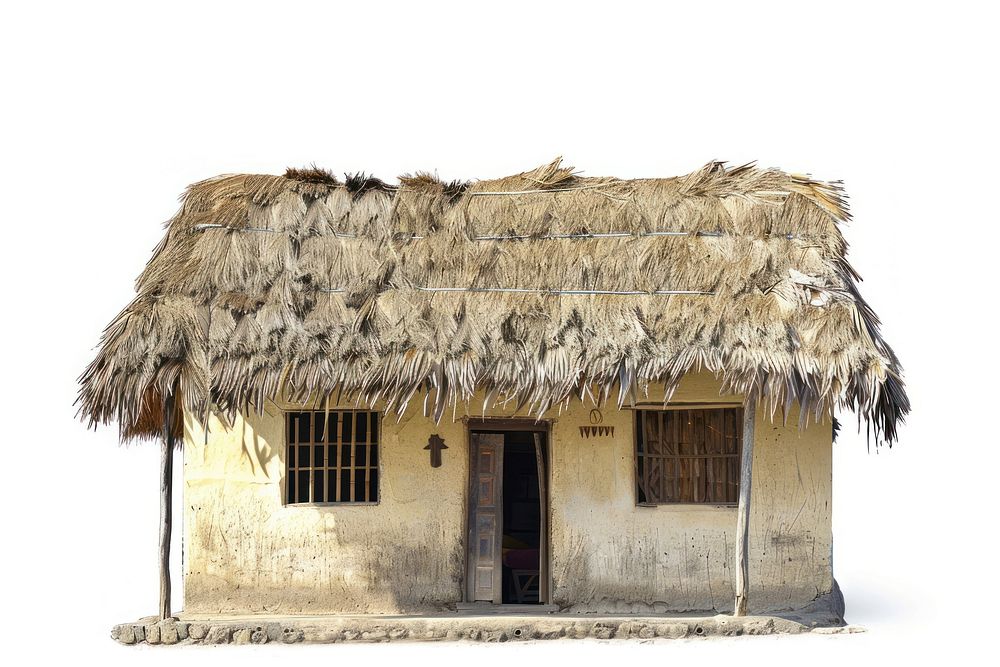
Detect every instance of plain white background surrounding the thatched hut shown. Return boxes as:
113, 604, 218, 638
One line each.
0, 1, 1000, 664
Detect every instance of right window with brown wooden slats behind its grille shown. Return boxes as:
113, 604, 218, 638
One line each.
635, 407, 743, 505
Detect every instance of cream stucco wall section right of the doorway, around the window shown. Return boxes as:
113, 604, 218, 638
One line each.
552, 374, 833, 612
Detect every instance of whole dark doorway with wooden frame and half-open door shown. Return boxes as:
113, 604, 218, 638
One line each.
466, 420, 549, 605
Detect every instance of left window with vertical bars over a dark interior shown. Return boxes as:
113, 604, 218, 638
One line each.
285, 410, 379, 504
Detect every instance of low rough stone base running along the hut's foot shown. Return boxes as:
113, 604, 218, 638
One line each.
111, 614, 863, 645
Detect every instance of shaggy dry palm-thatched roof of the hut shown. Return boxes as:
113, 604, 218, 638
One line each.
80, 160, 909, 442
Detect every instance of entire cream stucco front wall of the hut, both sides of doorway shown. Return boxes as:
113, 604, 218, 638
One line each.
183, 374, 832, 613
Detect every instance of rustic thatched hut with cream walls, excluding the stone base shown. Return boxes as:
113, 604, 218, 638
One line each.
79, 160, 909, 628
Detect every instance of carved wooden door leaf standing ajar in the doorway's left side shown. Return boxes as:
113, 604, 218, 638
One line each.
467, 431, 503, 604
